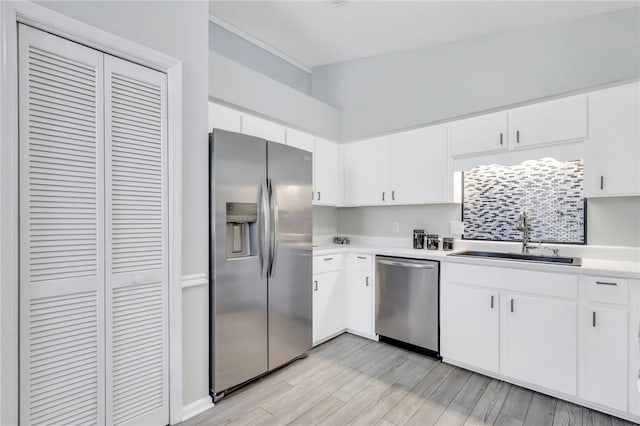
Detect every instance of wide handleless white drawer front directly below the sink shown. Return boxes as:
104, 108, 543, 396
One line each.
447, 263, 578, 299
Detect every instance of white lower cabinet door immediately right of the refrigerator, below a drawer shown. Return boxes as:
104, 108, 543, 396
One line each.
312, 271, 345, 345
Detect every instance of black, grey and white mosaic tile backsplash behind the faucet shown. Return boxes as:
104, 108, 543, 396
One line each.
462, 158, 585, 244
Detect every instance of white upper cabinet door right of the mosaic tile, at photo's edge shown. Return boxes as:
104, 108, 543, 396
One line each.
584, 83, 640, 197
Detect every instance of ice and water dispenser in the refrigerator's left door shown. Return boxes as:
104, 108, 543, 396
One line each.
227, 203, 258, 259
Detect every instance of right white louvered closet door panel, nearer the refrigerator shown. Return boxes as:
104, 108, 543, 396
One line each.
105, 55, 169, 425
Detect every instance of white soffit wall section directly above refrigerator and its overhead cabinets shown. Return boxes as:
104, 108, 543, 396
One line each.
209, 51, 341, 141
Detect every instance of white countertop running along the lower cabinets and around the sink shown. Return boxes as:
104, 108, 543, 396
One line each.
313, 243, 640, 279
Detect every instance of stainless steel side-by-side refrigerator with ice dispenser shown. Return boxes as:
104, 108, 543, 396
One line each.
210, 129, 312, 399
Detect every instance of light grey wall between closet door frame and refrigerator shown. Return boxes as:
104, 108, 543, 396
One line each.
40, 1, 209, 405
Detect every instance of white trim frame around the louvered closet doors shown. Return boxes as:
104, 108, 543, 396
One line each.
0, 2, 182, 424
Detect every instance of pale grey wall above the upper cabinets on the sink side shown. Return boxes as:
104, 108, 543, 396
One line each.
312, 8, 640, 140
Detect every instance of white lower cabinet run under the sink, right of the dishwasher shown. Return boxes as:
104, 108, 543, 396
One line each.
441, 263, 640, 417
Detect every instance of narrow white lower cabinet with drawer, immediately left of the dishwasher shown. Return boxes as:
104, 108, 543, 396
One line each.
346, 254, 375, 337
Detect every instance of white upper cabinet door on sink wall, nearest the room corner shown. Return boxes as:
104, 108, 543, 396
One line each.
344, 137, 391, 206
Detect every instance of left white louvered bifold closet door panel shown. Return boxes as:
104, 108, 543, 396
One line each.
18, 25, 105, 425
